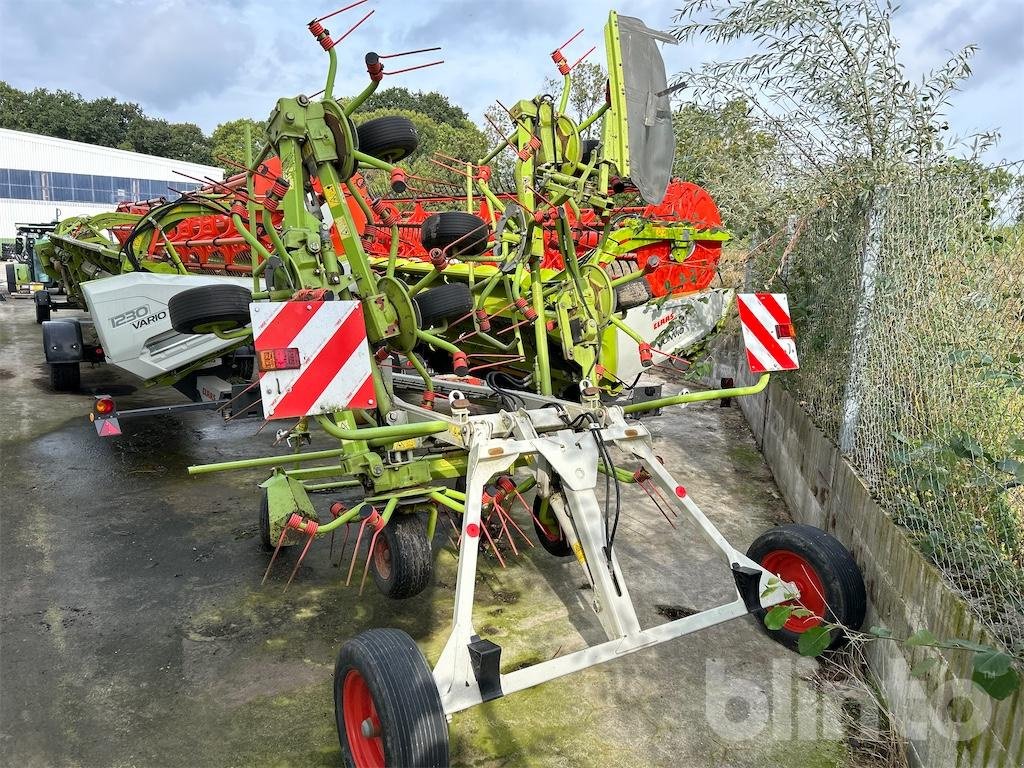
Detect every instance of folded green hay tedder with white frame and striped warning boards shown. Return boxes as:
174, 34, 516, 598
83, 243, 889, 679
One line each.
151, 7, 864, 766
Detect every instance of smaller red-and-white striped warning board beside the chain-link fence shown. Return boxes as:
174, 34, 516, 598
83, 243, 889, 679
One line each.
736, 293, 800, 374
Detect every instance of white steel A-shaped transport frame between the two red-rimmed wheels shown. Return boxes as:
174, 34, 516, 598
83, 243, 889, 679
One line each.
428, 403, 799, 716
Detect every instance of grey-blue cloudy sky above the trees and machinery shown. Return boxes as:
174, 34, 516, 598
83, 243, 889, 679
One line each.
0, 0, 1024, 160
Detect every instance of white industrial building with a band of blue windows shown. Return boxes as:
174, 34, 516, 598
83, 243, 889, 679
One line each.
0, 128, 223, 240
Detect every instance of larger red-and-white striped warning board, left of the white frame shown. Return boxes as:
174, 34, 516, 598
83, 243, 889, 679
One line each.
249, 301, 375, 419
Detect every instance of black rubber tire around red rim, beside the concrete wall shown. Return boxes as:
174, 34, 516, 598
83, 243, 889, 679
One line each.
746, 523, 867, 649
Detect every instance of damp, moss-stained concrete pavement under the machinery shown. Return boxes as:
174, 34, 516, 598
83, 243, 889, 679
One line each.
0, 299, 849, 768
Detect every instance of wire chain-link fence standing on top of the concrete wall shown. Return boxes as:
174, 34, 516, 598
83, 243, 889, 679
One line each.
745, 166, 1024, 657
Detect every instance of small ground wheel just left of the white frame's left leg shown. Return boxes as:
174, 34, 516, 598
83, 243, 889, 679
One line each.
370, 514, 434, 600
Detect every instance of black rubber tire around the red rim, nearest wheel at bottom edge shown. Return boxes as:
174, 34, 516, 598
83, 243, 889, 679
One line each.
334, 629, 449, 768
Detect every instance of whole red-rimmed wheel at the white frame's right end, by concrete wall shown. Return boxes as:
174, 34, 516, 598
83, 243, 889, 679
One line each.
746, 523, 867, 648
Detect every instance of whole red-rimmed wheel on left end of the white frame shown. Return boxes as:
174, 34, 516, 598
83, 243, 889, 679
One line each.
334, 629, 449, 768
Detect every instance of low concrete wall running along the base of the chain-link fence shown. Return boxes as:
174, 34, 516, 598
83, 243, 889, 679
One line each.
712, 345, 1024, 768
